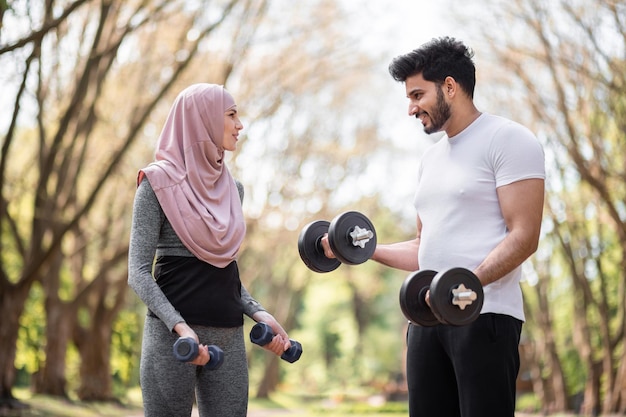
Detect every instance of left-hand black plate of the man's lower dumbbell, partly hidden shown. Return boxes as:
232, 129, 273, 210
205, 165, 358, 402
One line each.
400, 269, 440, 327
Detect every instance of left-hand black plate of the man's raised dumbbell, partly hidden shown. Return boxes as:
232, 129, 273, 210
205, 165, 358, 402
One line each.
298, 220, 341, 273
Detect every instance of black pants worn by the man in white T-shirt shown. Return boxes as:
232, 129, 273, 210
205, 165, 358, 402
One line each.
407, 314, 522, 417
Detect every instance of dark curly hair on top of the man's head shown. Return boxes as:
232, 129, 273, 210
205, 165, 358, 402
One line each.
389, 36, 476, 98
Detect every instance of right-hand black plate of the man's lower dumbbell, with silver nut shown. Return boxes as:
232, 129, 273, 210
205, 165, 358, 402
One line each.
430, 268, 484, 326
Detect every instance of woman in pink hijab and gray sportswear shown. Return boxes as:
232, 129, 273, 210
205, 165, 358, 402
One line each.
128, 84, 290, 417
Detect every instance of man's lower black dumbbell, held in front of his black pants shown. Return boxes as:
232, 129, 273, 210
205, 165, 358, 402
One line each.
400, 268, 484, 327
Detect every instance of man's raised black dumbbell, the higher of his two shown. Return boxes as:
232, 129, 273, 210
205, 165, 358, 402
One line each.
298, 211, 376, 272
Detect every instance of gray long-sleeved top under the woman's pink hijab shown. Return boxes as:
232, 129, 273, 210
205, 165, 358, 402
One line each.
128, 178, 265, 331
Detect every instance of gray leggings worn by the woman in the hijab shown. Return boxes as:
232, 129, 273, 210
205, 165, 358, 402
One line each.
140, 316, 248, 417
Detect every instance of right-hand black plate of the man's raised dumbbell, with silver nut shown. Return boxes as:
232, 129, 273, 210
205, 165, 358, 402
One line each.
328, 211, 376, 265
